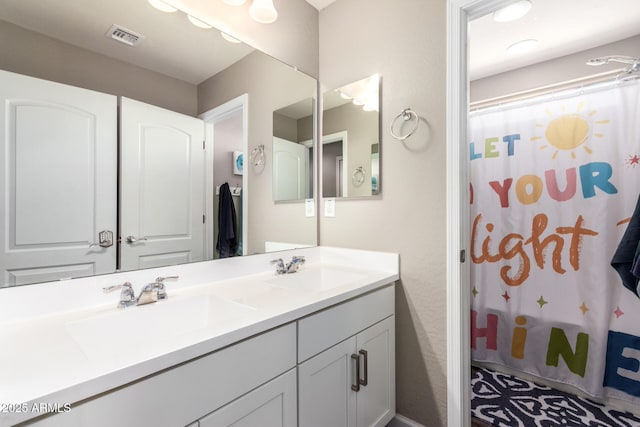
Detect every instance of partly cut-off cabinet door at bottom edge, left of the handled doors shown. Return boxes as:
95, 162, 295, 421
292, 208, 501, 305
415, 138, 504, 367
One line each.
200, 369, 298, 427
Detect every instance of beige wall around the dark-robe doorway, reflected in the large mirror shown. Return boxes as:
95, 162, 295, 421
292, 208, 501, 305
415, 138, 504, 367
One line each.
198, 52, 317, 254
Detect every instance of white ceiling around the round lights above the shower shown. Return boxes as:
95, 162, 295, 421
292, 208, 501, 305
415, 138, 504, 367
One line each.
307, 0, 640, 80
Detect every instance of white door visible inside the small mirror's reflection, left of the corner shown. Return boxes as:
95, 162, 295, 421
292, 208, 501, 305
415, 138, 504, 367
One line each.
273, 137, 309, 200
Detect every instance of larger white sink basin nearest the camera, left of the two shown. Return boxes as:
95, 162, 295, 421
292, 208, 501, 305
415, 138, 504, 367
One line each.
65, 295, 255, 360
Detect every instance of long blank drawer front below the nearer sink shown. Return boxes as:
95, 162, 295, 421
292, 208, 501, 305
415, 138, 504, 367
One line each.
29, 323, 296, 427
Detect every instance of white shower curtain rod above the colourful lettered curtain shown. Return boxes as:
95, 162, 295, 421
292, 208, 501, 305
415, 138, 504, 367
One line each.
469, 68, 640, 113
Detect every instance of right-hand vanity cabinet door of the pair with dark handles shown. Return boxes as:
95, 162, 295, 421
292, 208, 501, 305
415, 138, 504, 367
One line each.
356, 316, 396, 427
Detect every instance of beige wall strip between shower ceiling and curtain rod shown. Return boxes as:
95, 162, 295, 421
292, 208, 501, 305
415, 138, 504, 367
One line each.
470, 34, 640, 102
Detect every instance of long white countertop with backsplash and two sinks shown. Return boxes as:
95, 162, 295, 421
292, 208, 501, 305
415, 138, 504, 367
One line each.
0, 247, 399, 426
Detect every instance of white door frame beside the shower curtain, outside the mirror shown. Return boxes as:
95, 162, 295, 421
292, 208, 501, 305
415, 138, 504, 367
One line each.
446, 0, 516, 426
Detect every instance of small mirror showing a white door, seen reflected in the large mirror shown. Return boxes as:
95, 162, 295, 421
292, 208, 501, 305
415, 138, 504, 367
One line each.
273, 98, 315, 202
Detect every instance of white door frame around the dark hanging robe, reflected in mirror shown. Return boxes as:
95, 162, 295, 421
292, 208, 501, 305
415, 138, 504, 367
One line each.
198, 93, 249, 259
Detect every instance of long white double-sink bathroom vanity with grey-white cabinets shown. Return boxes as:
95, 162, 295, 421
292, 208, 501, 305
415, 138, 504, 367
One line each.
0, 247, 399, 427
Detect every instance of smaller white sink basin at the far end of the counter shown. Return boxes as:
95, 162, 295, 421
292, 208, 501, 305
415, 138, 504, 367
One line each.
265, 266, 366, 292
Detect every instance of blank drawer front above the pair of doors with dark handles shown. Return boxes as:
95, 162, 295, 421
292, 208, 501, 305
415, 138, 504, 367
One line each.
298, 285, 395, 363
